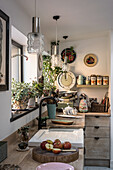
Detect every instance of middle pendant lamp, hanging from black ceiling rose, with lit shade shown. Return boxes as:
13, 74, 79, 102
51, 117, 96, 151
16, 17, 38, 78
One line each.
52, 15, 60, 67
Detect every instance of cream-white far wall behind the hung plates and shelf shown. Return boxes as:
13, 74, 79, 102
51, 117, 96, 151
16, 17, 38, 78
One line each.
60, 36, 110, 101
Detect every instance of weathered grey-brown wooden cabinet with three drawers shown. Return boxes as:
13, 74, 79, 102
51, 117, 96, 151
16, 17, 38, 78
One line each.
84, 116, 110, 167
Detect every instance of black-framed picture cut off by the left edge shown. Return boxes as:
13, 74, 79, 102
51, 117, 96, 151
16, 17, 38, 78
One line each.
0, 10, 9, 91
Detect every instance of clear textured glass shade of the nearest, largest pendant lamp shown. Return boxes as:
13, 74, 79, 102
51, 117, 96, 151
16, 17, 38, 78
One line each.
27, 32, 44, 54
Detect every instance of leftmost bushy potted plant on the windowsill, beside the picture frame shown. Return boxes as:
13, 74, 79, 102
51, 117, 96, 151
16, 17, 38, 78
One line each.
11, 79, 30, 109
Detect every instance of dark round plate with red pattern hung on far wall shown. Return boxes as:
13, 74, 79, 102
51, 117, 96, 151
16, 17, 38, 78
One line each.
61, 48, 76, 63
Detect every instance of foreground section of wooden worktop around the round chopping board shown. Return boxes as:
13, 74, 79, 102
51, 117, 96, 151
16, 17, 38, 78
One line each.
1, 122, 84, 170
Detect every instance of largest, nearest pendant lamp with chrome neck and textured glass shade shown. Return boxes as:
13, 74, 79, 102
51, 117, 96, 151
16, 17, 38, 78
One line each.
27, 0, 44, 54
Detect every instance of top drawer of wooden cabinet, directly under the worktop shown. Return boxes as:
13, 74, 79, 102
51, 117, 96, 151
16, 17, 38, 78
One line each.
85, 116, 110, 126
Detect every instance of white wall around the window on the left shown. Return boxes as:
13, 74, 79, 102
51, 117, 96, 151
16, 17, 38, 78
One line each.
0, 0, 47, 140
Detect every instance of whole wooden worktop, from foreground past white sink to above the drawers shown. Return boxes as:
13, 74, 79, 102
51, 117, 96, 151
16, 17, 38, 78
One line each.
1, 112, 110, 170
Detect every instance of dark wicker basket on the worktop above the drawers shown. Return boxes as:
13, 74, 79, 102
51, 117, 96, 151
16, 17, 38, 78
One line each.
91, 103, 105, 112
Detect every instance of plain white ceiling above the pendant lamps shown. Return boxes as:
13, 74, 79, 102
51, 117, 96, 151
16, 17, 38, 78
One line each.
16, 0, 113, 41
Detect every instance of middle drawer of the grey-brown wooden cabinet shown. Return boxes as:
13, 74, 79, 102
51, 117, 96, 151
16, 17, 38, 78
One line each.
85, 126, 110, 137
